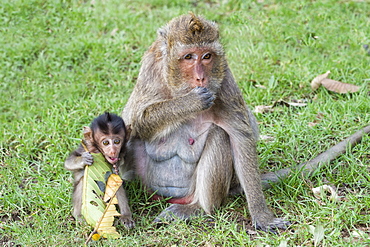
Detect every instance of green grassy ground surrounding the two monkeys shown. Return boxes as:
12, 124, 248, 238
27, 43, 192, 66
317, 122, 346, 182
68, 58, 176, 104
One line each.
0, 0, 370, 246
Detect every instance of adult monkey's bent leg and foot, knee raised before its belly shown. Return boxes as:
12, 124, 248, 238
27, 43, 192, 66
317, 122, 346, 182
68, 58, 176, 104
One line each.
154, 126, 233, 222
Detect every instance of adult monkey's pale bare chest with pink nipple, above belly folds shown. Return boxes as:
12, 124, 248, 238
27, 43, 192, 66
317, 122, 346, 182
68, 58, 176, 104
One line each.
145, 121, 212, 164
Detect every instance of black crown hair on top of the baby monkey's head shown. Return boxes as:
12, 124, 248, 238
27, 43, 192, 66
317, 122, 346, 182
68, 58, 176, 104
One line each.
90, 112, 126, 135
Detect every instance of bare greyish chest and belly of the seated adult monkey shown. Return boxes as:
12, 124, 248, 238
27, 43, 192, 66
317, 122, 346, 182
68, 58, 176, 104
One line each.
145, 124, 211, 198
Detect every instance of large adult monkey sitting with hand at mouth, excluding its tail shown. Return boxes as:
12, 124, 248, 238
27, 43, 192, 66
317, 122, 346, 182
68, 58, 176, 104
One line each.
122, 13, 289, 231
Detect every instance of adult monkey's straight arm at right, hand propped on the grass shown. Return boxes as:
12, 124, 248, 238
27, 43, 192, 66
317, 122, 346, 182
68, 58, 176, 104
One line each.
215, 74, 289, 231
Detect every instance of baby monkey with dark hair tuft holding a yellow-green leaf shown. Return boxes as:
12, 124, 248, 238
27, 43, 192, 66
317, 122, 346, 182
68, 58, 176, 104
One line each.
64, 112, 135, 228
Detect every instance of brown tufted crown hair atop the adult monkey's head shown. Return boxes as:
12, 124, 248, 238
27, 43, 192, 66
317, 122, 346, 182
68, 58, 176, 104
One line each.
158, 13, 219, 47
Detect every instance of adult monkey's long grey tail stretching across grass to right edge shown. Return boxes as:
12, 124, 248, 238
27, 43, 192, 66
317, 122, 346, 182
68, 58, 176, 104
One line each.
261, 125, 370, 189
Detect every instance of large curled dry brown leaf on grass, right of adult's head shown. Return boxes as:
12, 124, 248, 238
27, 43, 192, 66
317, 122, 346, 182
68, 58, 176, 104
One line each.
311, 71, 360, 93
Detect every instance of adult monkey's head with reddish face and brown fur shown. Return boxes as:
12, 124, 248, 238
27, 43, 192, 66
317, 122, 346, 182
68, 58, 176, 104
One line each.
158, 13, 226, 94
